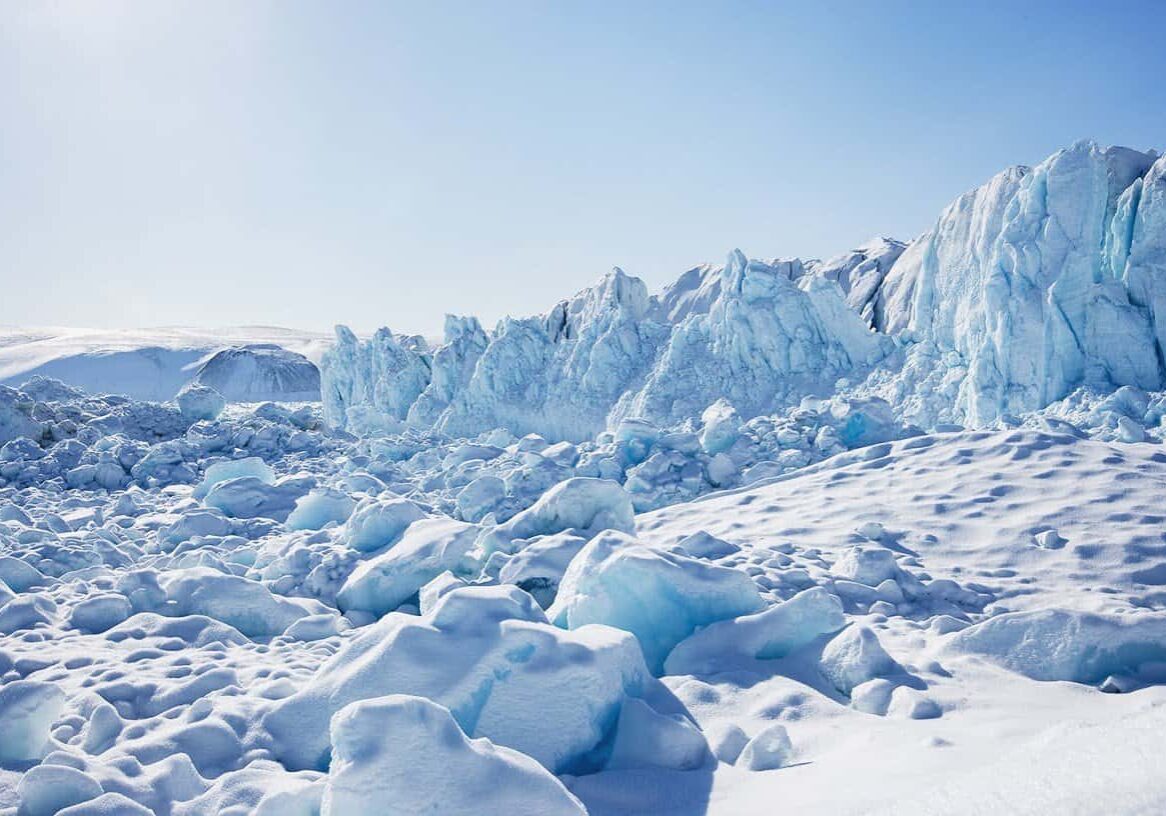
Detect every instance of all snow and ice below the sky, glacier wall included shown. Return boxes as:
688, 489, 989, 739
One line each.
0, 143, 1166, 816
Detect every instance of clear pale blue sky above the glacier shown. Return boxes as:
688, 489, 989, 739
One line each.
0, 0, 1166, 335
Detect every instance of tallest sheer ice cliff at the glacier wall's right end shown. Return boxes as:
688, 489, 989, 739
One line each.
873, 142, 1166, 425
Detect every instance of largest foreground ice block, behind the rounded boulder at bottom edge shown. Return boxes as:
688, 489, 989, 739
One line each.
264, 586, 649, 773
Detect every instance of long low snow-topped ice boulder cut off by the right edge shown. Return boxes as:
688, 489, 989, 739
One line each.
946, 610, 1166, 683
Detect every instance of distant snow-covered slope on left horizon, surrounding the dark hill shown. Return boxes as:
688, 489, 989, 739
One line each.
0, 326, 329, 400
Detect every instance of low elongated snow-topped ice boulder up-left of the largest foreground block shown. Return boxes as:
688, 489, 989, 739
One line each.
162, 567, 326, 638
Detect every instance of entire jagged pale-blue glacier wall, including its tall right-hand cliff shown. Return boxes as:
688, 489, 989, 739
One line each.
321, 142, 1166, 441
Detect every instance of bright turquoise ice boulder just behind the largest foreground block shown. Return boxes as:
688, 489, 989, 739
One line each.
548, 533, 765, 673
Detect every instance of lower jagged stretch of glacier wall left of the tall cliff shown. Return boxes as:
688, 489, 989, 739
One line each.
321, 259, 892, 441
